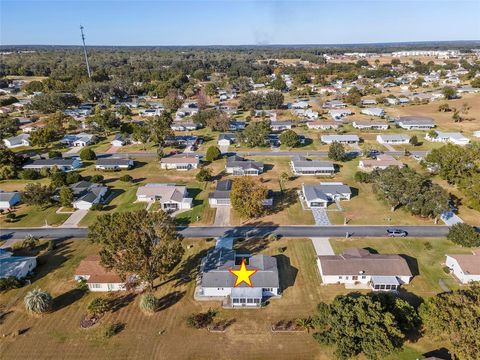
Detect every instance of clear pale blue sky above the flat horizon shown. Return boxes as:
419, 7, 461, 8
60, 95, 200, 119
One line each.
0, 0, 480, 45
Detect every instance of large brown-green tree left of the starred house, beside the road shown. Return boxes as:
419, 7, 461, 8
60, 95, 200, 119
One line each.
89, 210, 184, 289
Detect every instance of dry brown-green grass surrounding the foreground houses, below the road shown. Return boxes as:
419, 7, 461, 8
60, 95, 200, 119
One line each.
0, 239, 459, 360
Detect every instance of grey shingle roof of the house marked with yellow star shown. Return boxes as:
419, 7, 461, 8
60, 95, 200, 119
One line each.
202, 248, 280, 288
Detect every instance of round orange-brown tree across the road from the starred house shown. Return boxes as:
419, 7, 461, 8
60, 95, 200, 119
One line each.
230, 177, 267, 219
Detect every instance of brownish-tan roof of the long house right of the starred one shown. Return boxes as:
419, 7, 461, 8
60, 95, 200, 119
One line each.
318, 248, 412, 276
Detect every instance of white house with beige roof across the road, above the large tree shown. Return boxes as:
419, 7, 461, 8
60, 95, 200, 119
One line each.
137, 183, 193, 211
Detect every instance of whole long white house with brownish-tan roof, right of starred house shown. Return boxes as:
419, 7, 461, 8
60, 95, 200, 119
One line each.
317, 248, 413, 291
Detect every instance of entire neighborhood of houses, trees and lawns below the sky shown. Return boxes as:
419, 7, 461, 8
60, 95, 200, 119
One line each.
0, 37, 480, 359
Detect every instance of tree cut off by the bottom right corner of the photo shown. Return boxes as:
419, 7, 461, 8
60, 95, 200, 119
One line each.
419, 284, 480, 360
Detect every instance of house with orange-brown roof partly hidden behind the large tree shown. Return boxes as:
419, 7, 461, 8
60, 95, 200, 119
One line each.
74, 255, 136, 292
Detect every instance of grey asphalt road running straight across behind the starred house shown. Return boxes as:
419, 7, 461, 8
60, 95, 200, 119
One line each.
0, 225, 448, 240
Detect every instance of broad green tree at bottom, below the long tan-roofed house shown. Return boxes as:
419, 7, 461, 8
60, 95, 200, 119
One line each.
313, 295, 418, 359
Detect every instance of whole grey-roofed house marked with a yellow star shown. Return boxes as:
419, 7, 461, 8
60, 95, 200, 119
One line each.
195, 246, 281, 307
